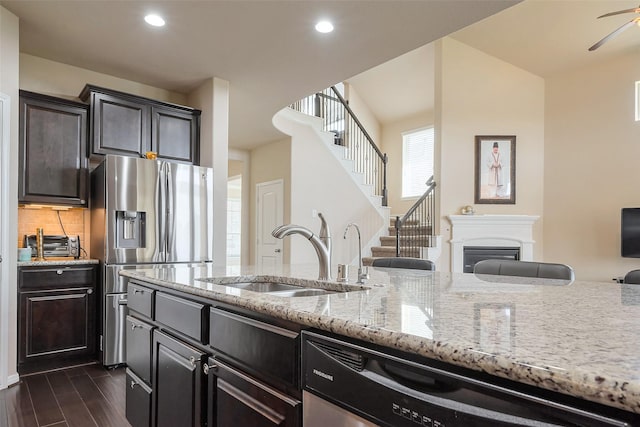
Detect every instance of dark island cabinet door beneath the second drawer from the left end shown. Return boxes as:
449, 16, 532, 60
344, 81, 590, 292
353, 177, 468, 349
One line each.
152, 330, 207, 427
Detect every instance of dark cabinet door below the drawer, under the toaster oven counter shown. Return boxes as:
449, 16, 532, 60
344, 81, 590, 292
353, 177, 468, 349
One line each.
18, 288, 96, 363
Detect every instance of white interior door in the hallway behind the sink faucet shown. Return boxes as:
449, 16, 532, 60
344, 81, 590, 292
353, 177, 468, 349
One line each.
256, 179, 284, 274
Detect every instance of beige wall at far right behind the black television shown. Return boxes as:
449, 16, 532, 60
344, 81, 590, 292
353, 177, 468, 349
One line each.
544, 52, 640, 281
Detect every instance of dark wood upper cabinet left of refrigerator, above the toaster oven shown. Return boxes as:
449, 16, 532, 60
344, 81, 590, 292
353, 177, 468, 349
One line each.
18, 91, 88, 206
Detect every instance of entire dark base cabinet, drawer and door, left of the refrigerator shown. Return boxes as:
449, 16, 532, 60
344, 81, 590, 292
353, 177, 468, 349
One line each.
18, 265, 96, 374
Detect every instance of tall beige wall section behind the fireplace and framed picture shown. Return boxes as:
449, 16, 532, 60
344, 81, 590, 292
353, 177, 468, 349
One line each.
435, 37, 544, 271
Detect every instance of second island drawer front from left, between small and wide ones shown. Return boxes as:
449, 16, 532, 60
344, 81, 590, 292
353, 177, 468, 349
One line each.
155, 292, 208, 344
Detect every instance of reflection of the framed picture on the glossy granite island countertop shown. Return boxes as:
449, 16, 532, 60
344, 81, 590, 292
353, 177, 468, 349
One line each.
474, 303, 516, 353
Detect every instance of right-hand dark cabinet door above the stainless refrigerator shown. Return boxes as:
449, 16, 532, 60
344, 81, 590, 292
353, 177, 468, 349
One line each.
151, 105, 200, 165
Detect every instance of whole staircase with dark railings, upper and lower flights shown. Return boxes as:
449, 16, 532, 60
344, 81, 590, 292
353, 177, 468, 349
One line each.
288, 87, 441, 265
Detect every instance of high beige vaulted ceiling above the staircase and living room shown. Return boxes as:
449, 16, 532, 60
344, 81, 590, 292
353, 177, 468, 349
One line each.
347, 0, 640, 124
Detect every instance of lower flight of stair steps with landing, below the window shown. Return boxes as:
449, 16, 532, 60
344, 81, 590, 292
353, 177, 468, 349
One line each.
362, 218, 435, 265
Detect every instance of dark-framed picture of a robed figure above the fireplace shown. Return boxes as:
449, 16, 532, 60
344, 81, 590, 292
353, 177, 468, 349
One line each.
475, 135, 516, 205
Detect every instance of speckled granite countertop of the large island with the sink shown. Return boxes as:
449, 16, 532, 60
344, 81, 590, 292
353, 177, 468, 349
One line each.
120, 266, 640, 413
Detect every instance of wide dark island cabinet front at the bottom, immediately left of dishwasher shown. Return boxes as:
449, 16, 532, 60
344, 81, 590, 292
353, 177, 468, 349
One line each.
208, 359, 302, 427
